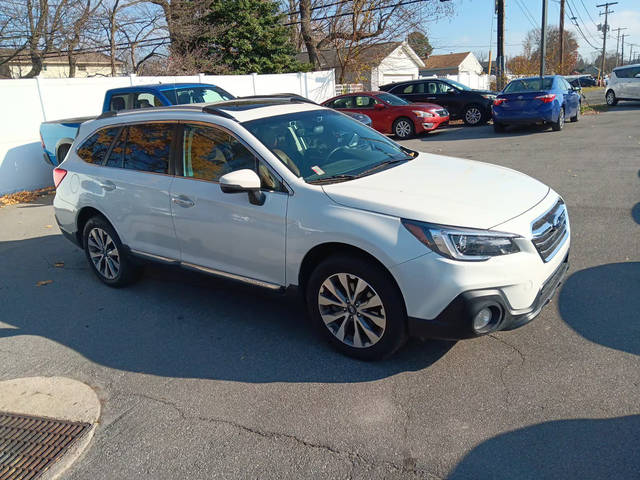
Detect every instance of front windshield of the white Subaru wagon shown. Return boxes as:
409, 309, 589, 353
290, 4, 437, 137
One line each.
243, 109, 414, 183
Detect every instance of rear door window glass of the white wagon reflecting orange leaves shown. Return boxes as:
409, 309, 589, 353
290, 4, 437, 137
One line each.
124, 123, 174, 173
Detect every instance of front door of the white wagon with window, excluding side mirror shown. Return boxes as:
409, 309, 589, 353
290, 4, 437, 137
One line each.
171, 124, 289, 285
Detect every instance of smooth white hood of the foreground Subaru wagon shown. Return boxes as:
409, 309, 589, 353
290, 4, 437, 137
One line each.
322, 153, 549, 229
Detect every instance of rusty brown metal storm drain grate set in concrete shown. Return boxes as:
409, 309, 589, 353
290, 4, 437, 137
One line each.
0, 412, 91, 480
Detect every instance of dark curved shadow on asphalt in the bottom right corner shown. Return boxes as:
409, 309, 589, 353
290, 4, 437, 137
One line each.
448, 415, 640, 480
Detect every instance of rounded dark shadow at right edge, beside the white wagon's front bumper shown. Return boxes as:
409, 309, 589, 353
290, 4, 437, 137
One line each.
558, 262, 640, 355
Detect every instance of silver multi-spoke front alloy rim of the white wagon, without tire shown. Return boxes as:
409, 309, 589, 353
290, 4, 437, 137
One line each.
318, 273, 387, 348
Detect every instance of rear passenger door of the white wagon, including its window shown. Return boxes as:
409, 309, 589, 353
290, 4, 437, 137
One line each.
94, 123, 179, 259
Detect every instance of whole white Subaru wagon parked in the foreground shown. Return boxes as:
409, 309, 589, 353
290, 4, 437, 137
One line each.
54, 98, 570, 359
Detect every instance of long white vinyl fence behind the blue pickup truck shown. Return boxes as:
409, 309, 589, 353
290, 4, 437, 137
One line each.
0, 70, 336, 195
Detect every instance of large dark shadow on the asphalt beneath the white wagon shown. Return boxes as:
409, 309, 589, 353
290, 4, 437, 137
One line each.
0, 235, 454, 382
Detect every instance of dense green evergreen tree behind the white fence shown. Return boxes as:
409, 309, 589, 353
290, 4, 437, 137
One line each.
200, 0, 308, 74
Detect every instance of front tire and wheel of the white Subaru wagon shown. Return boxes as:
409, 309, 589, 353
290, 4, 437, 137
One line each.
305, 255, 407, 360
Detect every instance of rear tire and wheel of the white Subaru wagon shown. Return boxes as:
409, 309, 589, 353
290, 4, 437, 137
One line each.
82, 216, 140, 287
